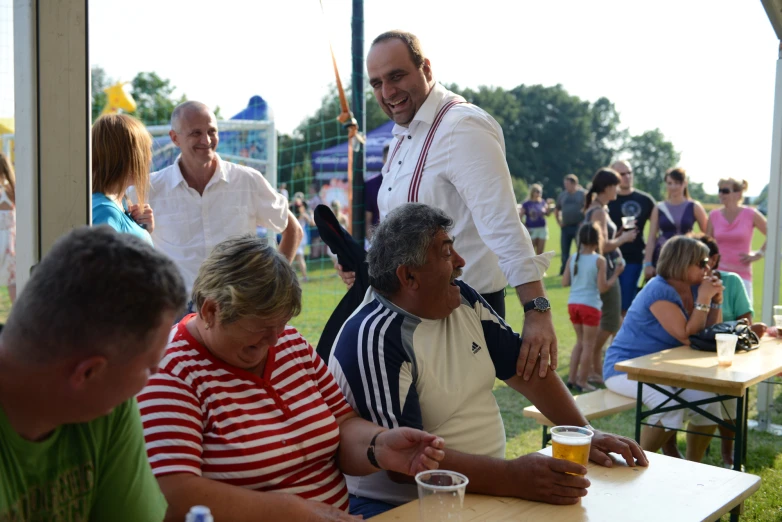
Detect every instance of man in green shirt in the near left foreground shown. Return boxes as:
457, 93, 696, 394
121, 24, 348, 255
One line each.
0, 227, 185, 522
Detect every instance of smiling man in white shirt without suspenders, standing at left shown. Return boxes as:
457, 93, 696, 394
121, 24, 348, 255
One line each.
135, 101, 303, 292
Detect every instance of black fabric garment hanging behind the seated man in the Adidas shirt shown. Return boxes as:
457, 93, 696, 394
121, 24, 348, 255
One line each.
315, 205, 369, 363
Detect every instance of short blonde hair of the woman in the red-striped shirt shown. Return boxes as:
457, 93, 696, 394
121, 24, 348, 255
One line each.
192, 234, 301, 324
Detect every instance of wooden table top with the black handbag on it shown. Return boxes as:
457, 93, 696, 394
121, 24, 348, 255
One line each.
614, 336, 782, 397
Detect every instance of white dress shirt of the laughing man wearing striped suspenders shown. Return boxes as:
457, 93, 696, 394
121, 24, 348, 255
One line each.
377, 83, 554, 294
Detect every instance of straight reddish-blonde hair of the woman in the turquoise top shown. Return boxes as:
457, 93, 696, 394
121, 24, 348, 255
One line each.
92, 114, 152, 205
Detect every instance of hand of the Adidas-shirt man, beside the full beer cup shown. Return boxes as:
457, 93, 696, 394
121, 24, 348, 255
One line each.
503, 453, 590, 504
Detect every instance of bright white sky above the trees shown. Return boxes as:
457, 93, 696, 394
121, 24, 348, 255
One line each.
0, 0, 778, 194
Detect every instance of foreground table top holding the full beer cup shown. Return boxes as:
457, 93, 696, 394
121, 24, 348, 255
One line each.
372, 447, 760, 522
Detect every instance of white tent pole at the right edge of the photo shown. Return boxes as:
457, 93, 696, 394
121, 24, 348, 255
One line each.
757, 42, 782, 431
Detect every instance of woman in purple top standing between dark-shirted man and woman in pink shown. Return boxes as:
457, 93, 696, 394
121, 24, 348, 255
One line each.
644, 167, 709, 280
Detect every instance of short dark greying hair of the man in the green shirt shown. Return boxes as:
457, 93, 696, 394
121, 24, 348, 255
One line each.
2, 225, 186, 364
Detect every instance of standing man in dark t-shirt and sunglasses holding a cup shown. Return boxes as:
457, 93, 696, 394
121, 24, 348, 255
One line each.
608, 161, 655, 317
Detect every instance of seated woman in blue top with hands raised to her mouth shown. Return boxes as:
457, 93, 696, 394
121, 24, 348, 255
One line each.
603, 236, 723, 462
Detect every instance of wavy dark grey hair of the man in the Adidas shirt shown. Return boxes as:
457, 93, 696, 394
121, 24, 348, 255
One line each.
367, 203, 453, 296
